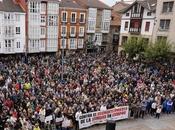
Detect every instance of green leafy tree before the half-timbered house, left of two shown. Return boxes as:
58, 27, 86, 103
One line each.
123, 37, 148, 58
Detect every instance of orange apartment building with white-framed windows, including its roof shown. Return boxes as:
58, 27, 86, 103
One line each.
59, 0, 87, 52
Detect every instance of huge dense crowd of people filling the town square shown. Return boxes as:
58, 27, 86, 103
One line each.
0, 53, 175, 130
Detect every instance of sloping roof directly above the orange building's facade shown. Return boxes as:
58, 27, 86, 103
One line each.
60, 0, 83, 8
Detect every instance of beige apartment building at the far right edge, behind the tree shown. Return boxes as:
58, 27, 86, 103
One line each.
153, 0, 175, 52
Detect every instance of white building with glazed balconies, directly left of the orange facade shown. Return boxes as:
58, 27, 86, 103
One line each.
18, 0, 59, 53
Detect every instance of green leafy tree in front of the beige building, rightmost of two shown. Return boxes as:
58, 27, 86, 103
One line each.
144, 39, 171, 61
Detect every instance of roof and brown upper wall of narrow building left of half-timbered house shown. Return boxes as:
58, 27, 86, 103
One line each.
111, 2, 129, 26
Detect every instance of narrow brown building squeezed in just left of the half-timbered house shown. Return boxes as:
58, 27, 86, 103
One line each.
109, 1, 129, 51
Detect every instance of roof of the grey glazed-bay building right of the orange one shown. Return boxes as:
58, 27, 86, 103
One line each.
76, 0, 112, 9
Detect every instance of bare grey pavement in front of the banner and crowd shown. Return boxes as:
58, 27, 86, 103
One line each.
84, 114, 175, 130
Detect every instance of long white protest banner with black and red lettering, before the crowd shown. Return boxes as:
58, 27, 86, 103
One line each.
78, 106, 129, 129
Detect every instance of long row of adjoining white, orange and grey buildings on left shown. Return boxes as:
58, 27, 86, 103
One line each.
0, 0, 111, 54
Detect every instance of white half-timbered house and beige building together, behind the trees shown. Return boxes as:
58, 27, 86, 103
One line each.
115, 0, 175, 51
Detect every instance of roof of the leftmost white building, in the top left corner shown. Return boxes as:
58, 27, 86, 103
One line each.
0, 0, 24, 13
